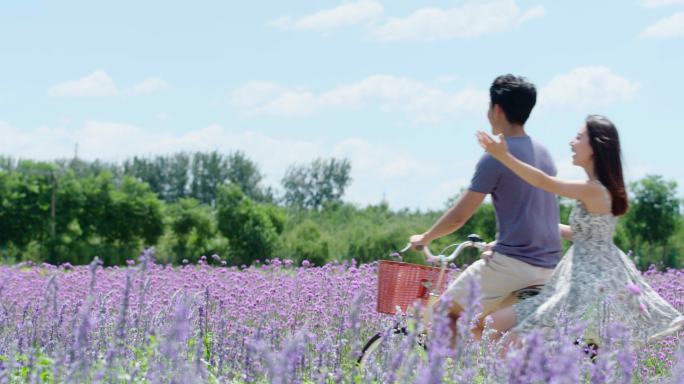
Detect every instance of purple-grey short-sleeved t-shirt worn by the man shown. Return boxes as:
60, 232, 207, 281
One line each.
469, 136, 561, 268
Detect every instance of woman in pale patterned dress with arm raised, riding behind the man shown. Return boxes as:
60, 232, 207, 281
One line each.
477, 116, 684, 343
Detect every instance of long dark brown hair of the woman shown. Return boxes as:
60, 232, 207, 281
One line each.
586, 115, 629, 216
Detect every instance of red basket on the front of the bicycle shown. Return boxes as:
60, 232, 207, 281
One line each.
377, 260, 447, 315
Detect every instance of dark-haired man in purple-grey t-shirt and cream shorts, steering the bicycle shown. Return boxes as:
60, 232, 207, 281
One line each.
410, 74, 561, 334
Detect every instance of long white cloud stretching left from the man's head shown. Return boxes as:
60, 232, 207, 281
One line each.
229, 75, 488, 123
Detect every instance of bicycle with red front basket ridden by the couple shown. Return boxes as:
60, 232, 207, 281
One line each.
357, 234, 543, 365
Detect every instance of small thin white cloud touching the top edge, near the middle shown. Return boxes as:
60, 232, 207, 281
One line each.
269, 0, 383, 31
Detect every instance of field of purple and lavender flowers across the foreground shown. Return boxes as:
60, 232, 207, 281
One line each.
0, 252, 684, 383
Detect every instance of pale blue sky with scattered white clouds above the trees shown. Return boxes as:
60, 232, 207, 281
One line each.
0, 0, 684, 208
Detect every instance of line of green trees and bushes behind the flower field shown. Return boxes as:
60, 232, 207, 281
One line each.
0, 152, 684, 268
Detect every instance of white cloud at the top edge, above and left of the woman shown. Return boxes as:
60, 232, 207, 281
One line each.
371, 0, 545, 41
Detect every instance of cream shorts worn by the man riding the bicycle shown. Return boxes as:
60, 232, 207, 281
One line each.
445, 252, 553, 313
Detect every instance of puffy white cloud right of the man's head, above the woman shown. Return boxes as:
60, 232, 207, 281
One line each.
539, 66, 639, 110
